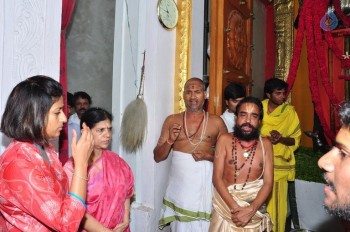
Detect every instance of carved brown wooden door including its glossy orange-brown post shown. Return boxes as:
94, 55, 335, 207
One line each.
209, 0, 253, 115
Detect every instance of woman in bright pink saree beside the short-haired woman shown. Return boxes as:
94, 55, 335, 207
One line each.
64, 107, 134, 232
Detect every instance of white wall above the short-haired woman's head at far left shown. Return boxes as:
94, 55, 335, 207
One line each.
0, 0, 62, 153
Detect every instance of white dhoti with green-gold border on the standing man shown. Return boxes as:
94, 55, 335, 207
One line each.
159, 151, 213, 232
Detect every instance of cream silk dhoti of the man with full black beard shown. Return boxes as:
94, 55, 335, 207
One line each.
209, 179, 272, 232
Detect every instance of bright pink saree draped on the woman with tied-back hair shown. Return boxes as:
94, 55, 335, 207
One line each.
64, 150, 134, 232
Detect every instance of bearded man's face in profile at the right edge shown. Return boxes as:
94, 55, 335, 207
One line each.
318, 102, 350, 225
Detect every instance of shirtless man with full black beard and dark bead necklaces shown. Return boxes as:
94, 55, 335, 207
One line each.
209, 97, 273, 232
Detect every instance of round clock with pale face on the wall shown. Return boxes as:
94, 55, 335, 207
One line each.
157, 0, 179, 29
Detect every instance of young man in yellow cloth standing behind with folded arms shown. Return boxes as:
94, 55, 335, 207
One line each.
261, 78, 301, 232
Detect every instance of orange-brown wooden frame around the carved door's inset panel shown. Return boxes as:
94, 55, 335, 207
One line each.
208, 0, 253, 115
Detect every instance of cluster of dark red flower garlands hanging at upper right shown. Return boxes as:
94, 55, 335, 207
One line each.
287, 0, 350, 141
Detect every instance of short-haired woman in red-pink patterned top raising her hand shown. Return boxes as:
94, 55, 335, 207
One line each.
0, 76, 93, 232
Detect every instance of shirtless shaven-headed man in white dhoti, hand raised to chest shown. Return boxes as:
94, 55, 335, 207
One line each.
153, 78, 227, 232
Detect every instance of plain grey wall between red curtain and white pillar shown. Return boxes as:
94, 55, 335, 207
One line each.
67, 0, 115, 111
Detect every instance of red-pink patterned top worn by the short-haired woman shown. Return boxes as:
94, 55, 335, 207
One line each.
0, 140, 85, 232
